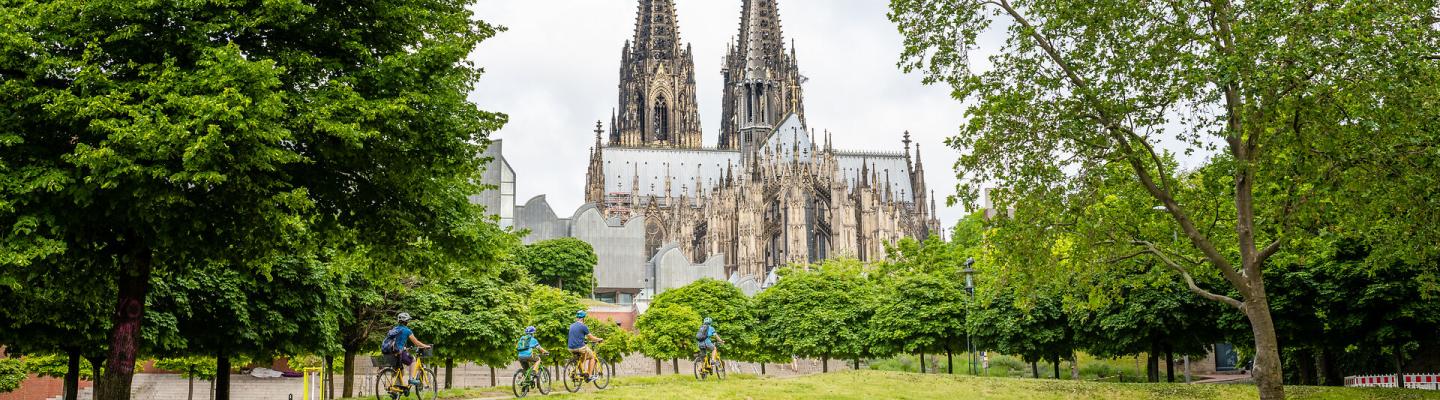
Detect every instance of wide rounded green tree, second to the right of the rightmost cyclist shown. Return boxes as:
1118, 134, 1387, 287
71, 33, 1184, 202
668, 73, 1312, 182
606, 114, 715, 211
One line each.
755, 259, 873, 370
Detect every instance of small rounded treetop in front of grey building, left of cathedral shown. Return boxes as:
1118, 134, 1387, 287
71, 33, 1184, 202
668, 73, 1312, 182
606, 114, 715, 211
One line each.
516, 237, 599, 296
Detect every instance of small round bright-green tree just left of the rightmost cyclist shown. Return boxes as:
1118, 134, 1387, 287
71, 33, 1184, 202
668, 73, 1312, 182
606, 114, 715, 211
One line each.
635, 304, 704, 360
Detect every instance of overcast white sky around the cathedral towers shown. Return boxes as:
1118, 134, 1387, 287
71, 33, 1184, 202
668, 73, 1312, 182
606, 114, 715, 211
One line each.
471, 0, 963, 226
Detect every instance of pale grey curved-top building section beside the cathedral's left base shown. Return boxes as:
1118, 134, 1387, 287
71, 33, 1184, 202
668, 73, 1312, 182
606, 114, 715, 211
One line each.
570, 204, 649, 292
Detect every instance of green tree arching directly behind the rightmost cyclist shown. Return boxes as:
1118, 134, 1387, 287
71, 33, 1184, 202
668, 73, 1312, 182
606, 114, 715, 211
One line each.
651, 278, 766, 361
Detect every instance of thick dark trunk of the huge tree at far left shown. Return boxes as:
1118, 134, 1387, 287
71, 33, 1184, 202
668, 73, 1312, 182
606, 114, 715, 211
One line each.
95, 249, 151, 400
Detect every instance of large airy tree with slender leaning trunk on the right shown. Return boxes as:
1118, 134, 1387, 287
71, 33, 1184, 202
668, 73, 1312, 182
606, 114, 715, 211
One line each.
890, 0, 1440, 399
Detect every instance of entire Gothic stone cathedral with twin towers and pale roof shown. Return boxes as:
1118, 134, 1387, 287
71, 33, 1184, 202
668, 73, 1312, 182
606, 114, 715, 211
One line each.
585, 0, 939, 281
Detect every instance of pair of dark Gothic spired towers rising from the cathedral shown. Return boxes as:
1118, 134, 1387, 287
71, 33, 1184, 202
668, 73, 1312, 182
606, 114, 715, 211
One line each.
609, 0, 805, 150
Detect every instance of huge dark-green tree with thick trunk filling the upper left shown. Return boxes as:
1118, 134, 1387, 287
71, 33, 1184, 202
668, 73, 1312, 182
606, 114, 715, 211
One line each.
0, 0, 504, 400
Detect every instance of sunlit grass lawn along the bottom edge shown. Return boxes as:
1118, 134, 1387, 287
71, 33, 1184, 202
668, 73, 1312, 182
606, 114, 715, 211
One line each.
524, 371, 1440, 400
